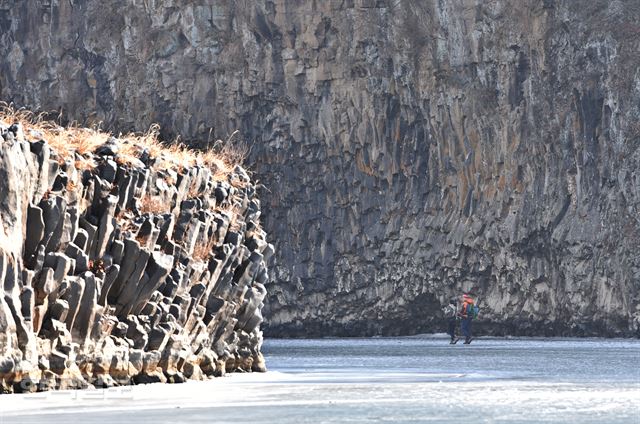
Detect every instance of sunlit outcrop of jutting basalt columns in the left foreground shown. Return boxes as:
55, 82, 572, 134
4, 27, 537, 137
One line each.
0, 117, 273, 392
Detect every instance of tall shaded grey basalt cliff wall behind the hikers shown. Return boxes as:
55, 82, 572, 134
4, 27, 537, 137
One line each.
0, 0, 640, 336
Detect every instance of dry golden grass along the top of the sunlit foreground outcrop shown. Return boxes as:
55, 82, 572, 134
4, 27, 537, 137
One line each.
0, 102, 248, 180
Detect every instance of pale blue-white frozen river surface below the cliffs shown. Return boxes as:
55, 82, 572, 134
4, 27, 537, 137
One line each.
0, 336, 640, 424
